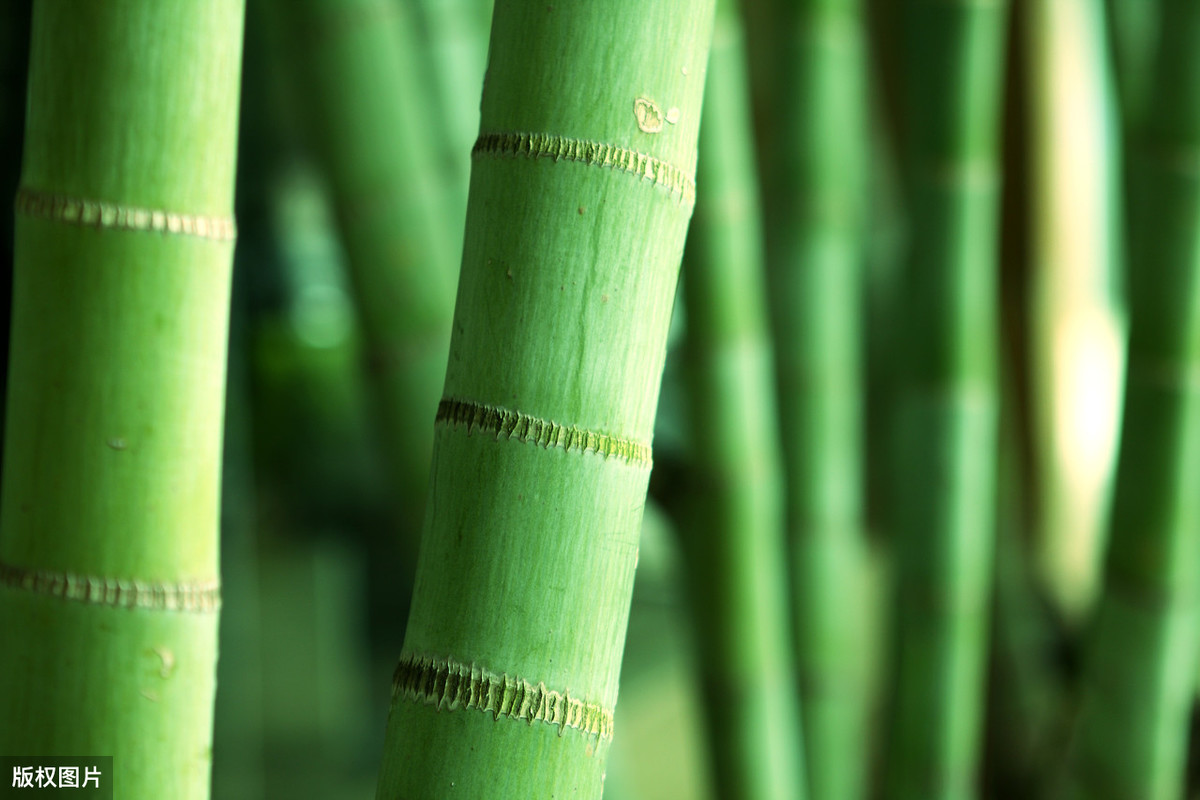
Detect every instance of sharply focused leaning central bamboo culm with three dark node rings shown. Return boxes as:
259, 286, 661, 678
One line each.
377, 0, 713, 800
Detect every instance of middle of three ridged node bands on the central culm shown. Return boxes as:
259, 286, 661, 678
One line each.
437, 398, 653, 467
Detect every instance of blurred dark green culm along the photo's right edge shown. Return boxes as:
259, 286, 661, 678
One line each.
1069, 0, 1200, 800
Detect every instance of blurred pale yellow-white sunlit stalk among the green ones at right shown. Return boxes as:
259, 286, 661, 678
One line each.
1018, 0, 1123, 622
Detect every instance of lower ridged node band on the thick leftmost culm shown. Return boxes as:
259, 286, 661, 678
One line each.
0, 561, 221, 614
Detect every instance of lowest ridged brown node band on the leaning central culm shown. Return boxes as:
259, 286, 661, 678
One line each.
391, 655, 612, 739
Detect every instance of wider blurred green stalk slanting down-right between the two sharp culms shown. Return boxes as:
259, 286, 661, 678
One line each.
271, 0, 462, 544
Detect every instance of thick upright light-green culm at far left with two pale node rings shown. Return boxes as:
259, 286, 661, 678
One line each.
0, 0, 244, 799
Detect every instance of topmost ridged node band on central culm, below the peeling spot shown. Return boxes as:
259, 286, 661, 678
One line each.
470, 133, 696, 206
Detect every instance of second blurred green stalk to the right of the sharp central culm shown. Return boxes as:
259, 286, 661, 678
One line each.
756, 0, 866, 800
